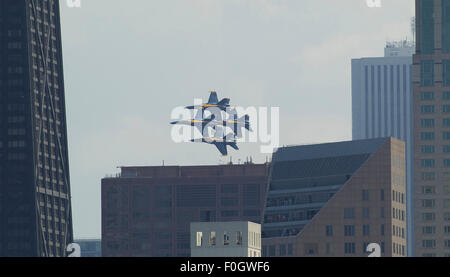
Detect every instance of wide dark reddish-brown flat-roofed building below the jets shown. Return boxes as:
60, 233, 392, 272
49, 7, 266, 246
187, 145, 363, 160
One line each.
102, 164, 269, 257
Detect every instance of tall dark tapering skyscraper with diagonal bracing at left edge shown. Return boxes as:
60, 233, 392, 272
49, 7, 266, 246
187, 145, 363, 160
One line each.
0, 0, 73, 257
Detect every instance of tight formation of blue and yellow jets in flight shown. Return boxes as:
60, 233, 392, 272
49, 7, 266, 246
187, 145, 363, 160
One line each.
170, 91, 252, 156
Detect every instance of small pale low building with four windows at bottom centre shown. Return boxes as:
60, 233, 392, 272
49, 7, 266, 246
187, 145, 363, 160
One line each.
191, 221, 261, 257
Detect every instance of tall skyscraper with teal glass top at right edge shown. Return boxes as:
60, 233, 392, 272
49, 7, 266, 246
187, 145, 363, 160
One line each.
413, 0, 450, 257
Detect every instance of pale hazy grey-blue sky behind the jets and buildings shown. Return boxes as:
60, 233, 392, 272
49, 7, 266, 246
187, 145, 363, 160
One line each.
60, 0, 414, 238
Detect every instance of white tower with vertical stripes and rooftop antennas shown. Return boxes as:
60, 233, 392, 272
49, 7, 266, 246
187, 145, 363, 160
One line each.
352, 41, 415, 256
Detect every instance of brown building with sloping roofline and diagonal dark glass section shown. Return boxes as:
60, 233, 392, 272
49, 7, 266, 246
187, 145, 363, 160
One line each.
262, 138, 407, 257
